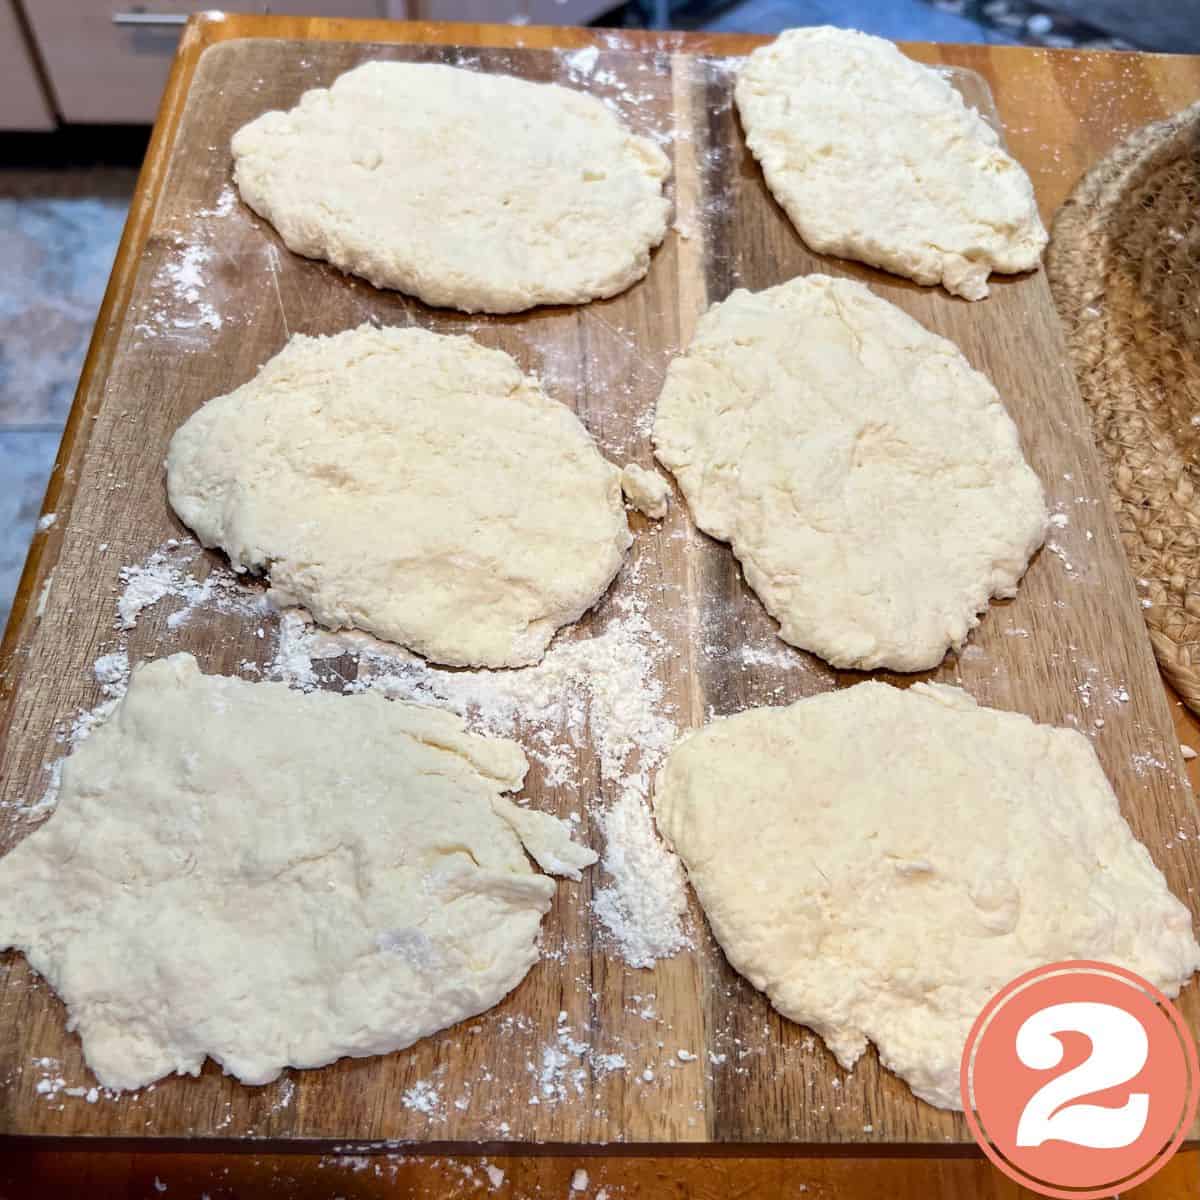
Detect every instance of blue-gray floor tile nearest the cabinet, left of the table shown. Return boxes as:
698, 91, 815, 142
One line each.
0, 184, 133, 428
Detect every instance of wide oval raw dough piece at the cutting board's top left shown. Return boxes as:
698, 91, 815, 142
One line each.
233, 62, 671, 312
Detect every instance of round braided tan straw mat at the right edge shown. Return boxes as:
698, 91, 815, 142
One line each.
1046, 104, 1200, 713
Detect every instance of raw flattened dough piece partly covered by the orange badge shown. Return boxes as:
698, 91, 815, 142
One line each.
655, 683, 1200, 1109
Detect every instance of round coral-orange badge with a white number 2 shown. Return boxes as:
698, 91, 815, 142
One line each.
961, 961, 1200, 1200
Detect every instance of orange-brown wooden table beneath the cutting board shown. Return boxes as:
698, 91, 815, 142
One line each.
0, 17, 1200, 1200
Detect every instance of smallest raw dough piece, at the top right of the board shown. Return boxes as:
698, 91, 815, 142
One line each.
736, 26, 1046, 300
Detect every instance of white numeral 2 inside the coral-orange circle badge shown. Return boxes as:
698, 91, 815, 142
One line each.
1016, 1001, 1150, 1150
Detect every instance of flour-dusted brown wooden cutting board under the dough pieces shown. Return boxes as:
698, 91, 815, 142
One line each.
0, 26, 1200, 1152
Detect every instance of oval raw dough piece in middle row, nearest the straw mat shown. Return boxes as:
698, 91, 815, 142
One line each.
654, 275, 1046, 671
